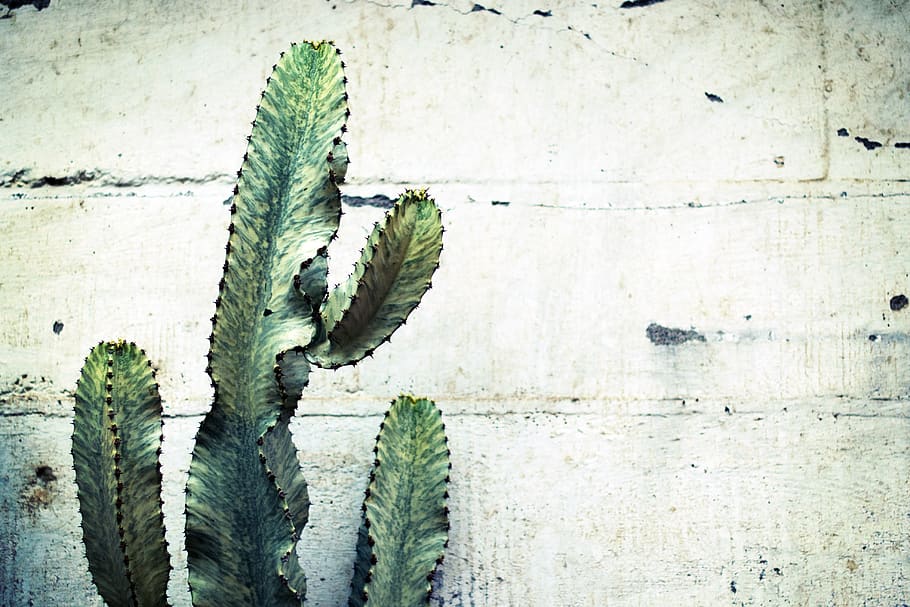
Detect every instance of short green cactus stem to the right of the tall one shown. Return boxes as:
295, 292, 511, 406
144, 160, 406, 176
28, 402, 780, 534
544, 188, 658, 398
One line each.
349, 396, 450, 607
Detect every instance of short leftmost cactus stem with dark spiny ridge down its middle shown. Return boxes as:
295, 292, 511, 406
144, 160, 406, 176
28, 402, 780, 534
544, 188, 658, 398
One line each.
72, 341, 170, 607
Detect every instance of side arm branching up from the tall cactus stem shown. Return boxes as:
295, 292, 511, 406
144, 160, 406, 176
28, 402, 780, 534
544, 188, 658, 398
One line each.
307, 190, 443, 368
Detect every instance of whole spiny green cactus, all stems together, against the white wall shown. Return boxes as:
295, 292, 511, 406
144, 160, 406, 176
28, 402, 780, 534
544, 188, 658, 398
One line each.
73, 42, 450, 607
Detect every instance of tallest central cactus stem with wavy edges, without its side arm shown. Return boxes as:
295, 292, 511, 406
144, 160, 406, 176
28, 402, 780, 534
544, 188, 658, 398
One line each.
186, 43, 347, 607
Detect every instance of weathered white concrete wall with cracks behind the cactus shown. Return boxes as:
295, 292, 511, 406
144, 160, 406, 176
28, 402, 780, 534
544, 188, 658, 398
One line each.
0, 0, 910, 607
